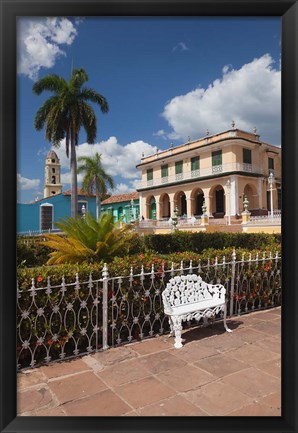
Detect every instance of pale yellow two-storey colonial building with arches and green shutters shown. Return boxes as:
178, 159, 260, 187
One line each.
137, 123, 281, 222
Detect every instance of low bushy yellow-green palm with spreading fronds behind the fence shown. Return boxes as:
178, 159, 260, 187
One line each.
41, 212, 132, 265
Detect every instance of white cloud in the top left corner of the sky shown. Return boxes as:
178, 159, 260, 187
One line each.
17, 17, 79, 80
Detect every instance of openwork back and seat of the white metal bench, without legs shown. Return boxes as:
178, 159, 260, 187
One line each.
162, 274, 226, 314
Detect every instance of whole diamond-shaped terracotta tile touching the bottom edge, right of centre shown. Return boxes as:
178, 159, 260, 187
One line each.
184, 381, 252, 416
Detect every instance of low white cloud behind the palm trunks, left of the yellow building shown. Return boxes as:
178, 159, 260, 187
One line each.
55, 137, 156, 189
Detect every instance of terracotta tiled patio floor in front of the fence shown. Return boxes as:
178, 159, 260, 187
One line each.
18, 308, 281, 416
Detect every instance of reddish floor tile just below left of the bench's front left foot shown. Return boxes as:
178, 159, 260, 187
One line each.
139, 352, 186, 374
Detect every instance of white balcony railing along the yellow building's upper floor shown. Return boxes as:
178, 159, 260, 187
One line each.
137, 162, 264, 189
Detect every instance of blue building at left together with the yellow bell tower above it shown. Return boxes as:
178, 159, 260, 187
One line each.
17, 150, 96, 234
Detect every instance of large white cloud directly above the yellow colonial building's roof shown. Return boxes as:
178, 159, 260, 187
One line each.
162, 54, 281, 144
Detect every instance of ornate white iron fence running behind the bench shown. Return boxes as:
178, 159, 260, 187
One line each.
17, 251, 281, 369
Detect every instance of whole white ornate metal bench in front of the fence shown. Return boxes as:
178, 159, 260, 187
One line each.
162, 274, 232, 349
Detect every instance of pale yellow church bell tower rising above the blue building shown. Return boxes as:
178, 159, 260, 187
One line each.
43, 150, 62, 198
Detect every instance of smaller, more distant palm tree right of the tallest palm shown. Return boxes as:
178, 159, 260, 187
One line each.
77, 152, 114, 219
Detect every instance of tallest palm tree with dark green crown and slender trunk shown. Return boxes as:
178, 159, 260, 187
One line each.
33, 68, 109, 218
